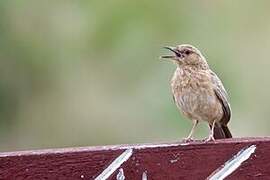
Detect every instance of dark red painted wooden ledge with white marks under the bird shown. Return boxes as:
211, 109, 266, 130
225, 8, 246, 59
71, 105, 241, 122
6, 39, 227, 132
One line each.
0, 137, 270, 180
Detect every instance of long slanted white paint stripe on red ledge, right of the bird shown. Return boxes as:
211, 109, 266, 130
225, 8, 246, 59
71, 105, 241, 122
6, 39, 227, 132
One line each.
207, 145, 256, 180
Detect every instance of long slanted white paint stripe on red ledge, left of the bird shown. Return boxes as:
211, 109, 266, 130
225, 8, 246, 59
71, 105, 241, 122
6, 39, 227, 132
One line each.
95, 149, 133, 180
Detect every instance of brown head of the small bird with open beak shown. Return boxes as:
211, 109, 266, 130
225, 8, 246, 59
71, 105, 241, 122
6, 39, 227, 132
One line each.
161, 44, 207, 66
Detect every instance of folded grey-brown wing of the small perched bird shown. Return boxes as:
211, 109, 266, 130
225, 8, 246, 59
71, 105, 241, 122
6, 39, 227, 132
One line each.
210, 71, 231, 125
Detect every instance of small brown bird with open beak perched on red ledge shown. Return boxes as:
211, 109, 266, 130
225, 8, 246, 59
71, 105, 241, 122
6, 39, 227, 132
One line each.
161, 44, 232, 141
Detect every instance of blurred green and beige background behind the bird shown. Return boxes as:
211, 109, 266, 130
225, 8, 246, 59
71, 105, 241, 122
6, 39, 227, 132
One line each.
0, 0, 270, 151
